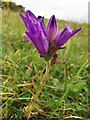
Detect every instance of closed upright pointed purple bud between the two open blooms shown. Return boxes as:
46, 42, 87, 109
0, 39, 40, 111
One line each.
46, 15, 57, 42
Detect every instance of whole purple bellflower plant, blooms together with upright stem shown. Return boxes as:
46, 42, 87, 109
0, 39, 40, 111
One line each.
20, 10, 81, 119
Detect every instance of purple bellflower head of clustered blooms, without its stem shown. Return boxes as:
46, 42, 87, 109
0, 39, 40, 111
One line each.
19, 10, 81, 63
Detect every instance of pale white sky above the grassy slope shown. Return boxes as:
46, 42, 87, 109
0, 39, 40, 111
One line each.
12, 0, 89, 22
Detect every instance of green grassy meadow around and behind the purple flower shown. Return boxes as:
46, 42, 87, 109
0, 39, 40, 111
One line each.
0, 10, 90, 120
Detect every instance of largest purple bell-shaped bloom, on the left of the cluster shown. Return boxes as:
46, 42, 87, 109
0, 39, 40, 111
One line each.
19, 10, 49, 55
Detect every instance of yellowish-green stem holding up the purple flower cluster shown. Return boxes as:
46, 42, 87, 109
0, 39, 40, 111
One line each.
26, 61, 49, 119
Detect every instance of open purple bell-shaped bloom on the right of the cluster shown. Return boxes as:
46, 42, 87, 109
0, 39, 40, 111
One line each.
55, 23, 81, 47
